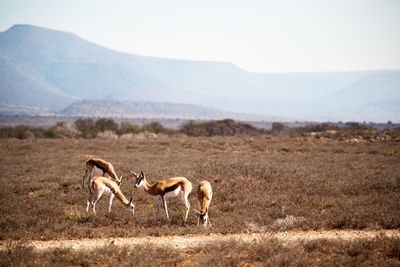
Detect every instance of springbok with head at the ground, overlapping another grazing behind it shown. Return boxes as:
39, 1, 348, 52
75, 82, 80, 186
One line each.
86, 176, 135, 215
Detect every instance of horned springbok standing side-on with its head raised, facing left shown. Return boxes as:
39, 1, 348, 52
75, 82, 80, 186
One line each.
132, 171, 192, 223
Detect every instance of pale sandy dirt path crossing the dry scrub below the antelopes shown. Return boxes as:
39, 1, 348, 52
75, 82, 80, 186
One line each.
0, 230, 400, 250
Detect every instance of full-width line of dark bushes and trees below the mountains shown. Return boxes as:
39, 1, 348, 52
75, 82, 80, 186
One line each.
0, 118, 400, 140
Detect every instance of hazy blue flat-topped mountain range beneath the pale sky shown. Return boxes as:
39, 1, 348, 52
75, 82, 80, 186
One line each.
0, 25, 400, 122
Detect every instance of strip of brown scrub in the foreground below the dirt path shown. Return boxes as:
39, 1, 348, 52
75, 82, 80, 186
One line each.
0, 236, 400, 266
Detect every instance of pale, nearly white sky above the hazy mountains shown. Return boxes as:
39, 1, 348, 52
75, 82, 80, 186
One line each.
0, 0, 400, 72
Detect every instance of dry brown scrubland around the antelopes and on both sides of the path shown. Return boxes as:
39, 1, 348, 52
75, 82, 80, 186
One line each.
0, 135, 400, 265
